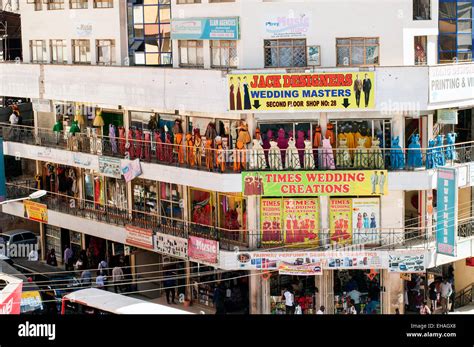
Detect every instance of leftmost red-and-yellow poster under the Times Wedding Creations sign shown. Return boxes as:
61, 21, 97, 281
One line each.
260, 199, 283, 246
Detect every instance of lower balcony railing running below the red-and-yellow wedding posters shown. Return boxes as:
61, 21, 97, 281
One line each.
7, 181, 434, 251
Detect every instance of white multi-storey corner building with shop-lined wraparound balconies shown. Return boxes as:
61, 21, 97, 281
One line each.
0, 0, 474, 313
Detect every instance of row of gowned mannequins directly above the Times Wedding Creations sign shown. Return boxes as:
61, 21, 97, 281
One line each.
249, 123, 384, 170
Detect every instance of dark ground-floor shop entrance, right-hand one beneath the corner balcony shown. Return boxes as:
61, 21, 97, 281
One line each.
334, 270, 382, 314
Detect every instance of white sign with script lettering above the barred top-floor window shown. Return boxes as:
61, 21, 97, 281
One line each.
264, 10, 311, 39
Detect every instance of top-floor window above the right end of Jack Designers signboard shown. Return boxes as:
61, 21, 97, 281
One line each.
336, 37, 380, 66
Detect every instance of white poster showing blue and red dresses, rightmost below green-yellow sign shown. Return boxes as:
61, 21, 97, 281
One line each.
352, 198, 381, 245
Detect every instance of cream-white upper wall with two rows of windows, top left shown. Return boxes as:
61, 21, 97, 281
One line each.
20, 0, 128, 65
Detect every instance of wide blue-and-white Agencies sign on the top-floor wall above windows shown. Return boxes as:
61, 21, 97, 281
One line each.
171, 17, 239, 40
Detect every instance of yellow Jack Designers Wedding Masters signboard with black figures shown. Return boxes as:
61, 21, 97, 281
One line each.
227, 72, 376, 112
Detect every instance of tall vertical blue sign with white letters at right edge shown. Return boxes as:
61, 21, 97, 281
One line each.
436, 168, 458, 257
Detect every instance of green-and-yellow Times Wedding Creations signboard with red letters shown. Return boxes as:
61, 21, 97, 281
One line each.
242, 170, 388, 197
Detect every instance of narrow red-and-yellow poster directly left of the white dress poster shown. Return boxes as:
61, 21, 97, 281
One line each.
329, 198, 352, 245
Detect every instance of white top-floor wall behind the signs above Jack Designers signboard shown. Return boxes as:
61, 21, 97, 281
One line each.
171, 0, 438, 69
